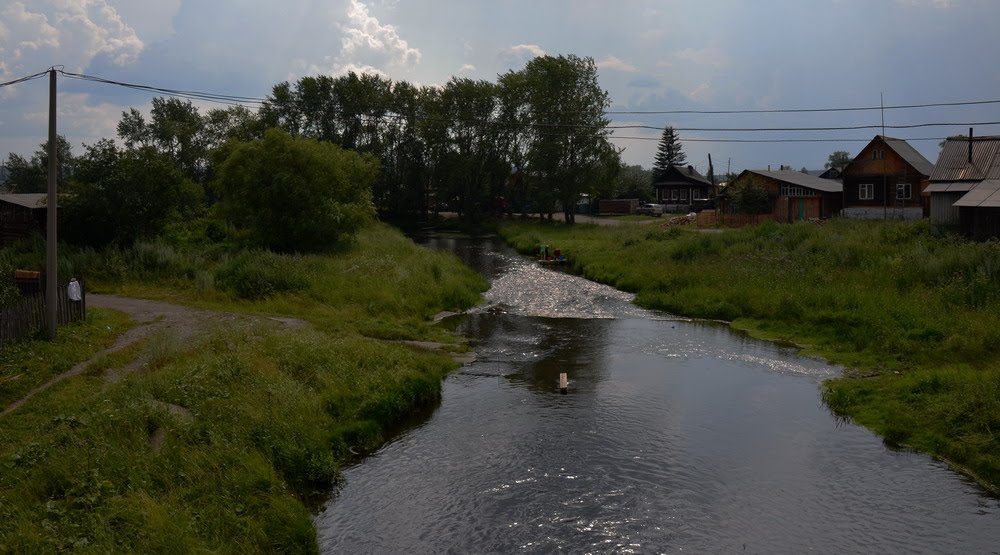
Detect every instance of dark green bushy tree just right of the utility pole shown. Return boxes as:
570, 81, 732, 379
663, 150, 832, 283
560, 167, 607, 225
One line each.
59, 139, 203, 247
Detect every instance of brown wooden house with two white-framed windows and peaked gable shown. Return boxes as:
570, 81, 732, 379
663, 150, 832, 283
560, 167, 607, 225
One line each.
841, 135, 934, 220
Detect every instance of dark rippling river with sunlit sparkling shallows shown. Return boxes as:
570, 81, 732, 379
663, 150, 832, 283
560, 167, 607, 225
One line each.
316, 237, 1000, 553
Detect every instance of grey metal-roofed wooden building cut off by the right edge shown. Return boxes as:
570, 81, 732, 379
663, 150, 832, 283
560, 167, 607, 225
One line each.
927, 134, 1000, 239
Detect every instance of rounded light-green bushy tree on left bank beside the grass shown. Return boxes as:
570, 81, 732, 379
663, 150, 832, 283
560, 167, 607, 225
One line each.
215, 129, 378, 252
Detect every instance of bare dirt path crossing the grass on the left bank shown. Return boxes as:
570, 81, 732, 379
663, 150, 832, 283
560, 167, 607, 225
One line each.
0, 295, 306, 416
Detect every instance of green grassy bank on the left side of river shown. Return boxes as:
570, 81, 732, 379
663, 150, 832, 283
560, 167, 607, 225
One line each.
0, 222, 485, 552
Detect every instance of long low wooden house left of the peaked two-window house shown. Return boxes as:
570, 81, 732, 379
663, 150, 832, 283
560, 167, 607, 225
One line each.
722, 170, 843, 223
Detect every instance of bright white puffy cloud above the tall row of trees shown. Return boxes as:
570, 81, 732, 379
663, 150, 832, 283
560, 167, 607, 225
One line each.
340, 0, 421, 66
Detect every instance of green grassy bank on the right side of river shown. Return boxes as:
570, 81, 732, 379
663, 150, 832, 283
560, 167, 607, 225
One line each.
501, 221, 1000, 489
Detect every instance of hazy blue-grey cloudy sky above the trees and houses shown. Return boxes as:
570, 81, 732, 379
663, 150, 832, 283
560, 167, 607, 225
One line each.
0, 0, 1000, 174
